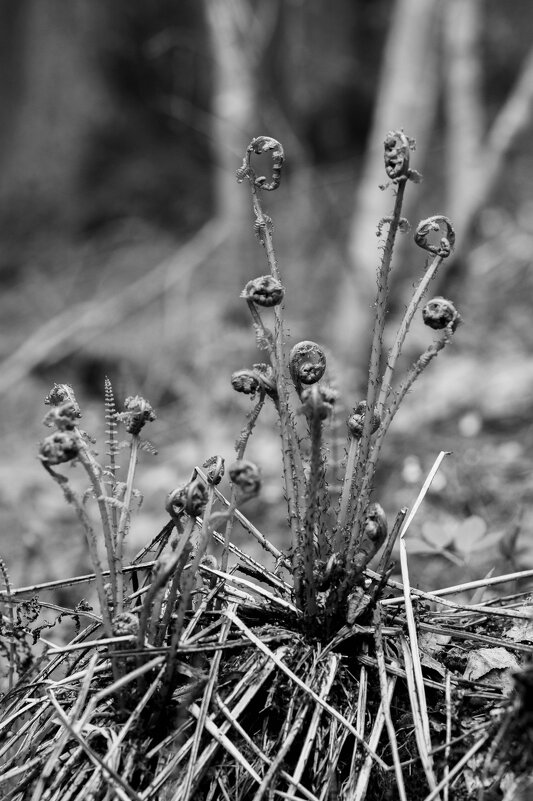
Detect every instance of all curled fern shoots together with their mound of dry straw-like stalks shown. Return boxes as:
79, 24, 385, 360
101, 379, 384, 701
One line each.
0, 131, 533, 801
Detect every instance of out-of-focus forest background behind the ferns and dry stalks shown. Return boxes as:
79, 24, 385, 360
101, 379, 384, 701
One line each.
0, 0, 533, 600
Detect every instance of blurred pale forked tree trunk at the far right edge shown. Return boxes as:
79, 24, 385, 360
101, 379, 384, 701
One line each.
435, 0, 533, 298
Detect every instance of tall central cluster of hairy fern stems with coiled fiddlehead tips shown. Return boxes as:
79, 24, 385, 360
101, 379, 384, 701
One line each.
232, 131, 459, 631
